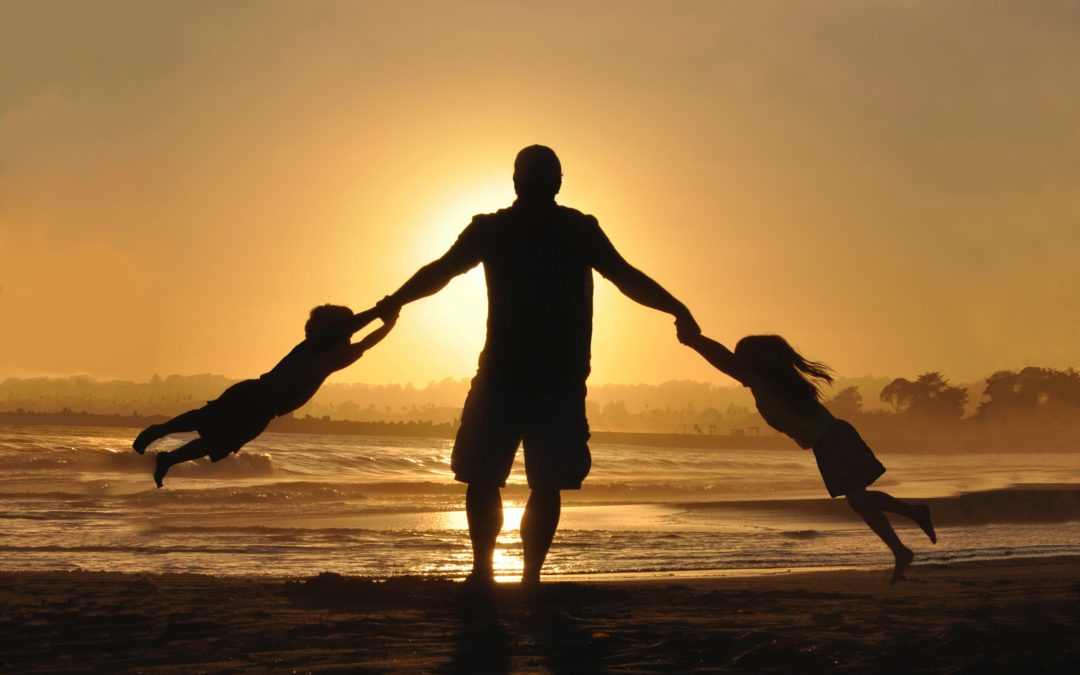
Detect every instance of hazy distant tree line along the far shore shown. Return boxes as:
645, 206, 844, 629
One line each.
0, 366, 1080, 436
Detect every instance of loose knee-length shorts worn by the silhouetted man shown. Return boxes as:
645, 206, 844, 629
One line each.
450, 378, 592, 490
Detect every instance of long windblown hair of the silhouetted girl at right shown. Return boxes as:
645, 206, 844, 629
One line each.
734, 335, 833, 401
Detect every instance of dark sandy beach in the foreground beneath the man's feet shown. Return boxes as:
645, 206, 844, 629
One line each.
0, 557, 1080, 673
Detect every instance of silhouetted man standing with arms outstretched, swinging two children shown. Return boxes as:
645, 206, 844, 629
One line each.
378, 146, 697, 583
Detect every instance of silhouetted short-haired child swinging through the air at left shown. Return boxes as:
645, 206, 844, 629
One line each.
132, 305, 396, 487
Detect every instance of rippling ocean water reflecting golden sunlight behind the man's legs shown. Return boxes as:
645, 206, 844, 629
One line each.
0, 426, 1080, 580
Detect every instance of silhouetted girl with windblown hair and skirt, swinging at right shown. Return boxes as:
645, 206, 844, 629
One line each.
679, 334, 937, 583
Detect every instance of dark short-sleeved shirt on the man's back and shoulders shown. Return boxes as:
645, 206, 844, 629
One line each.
447, 198, 623, 389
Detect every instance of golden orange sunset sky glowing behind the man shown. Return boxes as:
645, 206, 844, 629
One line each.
0, 0, 1080, 386
